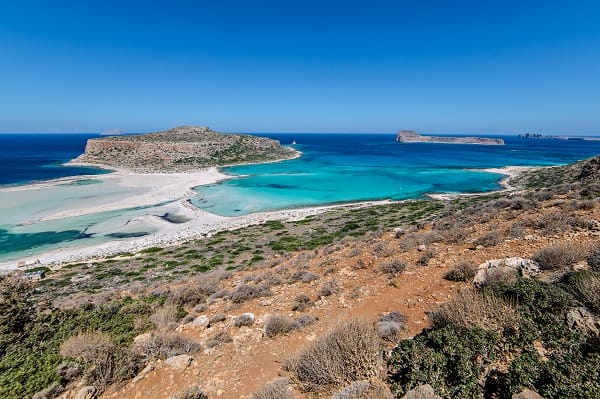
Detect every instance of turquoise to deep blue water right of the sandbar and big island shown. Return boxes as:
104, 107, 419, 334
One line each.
192, 134, 600, 216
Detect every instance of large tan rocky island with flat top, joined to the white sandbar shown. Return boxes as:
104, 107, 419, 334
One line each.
70, 126, 298, 173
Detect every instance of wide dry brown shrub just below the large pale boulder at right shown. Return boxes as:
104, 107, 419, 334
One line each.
429, 289, 518, 331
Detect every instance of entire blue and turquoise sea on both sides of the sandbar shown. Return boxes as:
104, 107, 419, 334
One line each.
0, 133, 600, 261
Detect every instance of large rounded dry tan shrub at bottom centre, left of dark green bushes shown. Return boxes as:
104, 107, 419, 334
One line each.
284, 320, 382, 392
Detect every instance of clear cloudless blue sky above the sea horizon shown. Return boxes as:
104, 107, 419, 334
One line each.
0, 0, 600, 135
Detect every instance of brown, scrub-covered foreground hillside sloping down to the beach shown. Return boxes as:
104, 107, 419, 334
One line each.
0, 158, 600, 399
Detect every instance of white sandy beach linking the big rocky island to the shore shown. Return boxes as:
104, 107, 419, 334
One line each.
0, 163, 389, 271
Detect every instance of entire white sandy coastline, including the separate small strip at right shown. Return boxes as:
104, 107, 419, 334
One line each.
0, 161, 535, 271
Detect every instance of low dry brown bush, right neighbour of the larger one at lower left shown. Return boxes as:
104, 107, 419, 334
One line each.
134, 331, 200, 359
